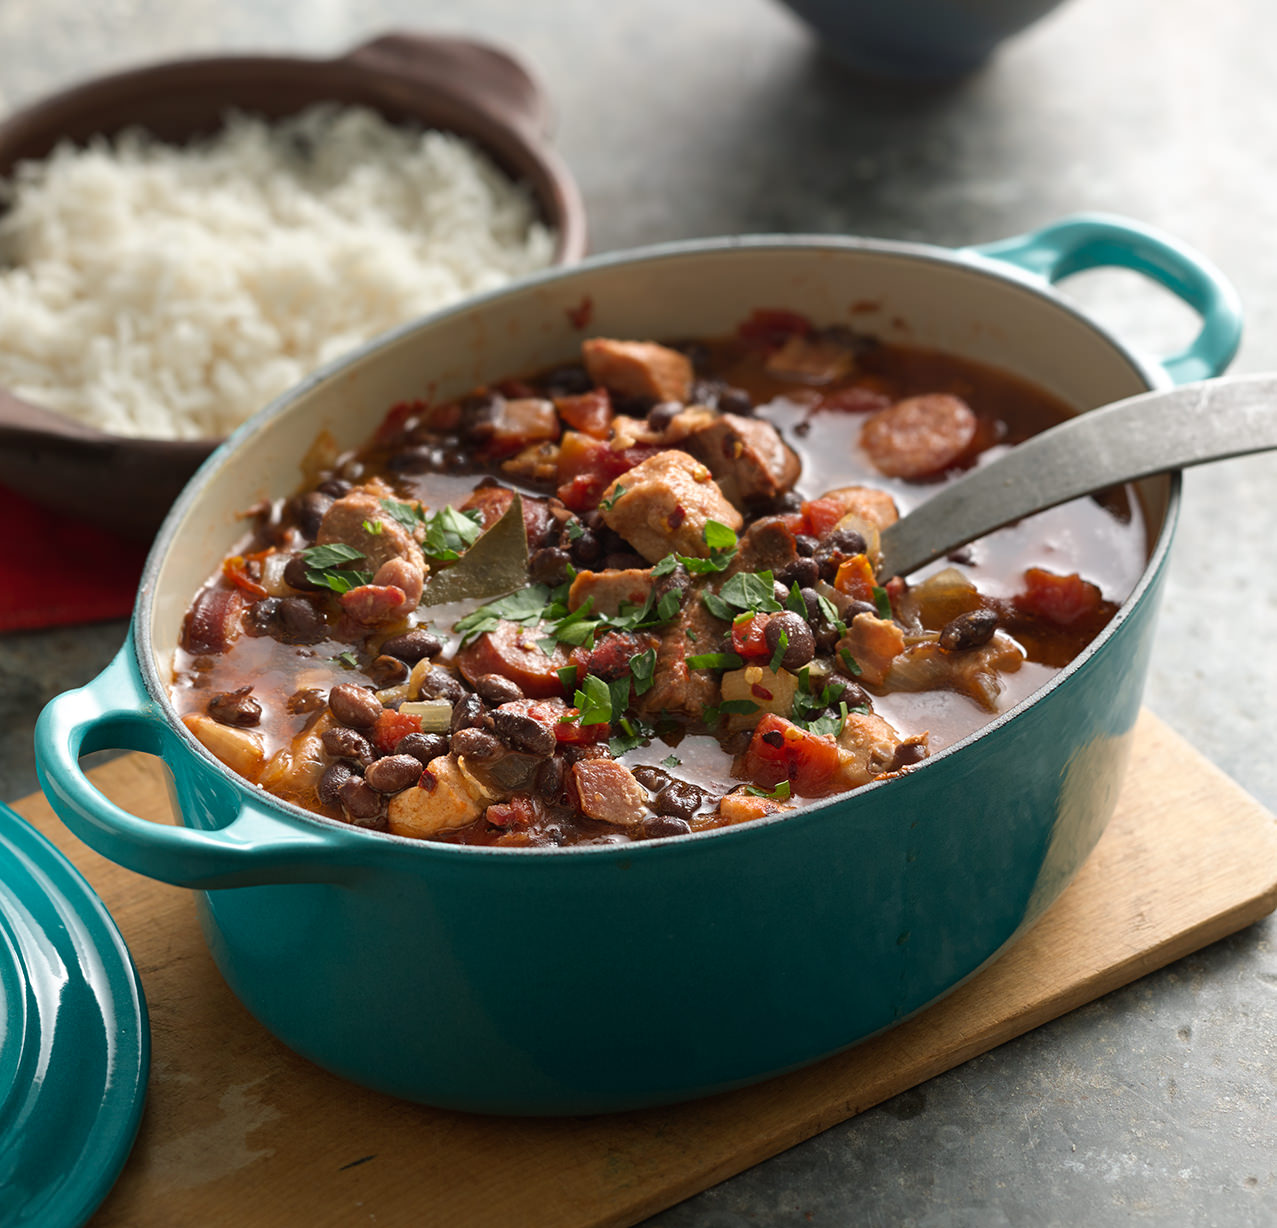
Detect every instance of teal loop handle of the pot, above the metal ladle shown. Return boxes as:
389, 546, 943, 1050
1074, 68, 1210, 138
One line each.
967, 213, 1241, 384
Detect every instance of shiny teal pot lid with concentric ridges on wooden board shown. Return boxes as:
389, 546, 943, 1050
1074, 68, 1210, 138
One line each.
0, 804, 151, 1228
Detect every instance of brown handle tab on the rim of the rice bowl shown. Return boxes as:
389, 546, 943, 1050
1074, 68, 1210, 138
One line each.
341, 31, 552, 140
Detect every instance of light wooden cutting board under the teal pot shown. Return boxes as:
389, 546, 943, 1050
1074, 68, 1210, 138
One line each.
15, 714, 1277, 1228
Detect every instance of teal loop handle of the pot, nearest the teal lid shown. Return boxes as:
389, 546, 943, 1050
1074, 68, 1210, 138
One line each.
36, 641, 354, 888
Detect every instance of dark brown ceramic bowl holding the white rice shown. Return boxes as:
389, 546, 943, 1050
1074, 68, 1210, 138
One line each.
0, 33, 585, 537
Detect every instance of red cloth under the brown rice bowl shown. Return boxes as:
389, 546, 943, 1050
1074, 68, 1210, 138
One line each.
0, 486, 148, 632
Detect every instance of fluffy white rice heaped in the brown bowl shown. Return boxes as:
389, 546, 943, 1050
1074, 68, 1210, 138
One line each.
0, 105, 554, 439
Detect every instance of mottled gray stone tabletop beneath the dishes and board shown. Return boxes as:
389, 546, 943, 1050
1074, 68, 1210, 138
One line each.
0, 0, 1277, 1228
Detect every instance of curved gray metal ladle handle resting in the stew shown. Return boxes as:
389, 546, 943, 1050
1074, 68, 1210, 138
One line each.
879, 374, 1277, 577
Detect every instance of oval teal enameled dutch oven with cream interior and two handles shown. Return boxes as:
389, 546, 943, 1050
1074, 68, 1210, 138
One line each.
36, 216, 1240, 1113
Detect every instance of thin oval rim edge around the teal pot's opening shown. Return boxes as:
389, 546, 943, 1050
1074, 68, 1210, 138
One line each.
129, 234, 1183, 863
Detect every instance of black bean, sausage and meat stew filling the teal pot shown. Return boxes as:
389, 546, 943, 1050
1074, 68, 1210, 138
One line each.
172, 310, 1147, 846
